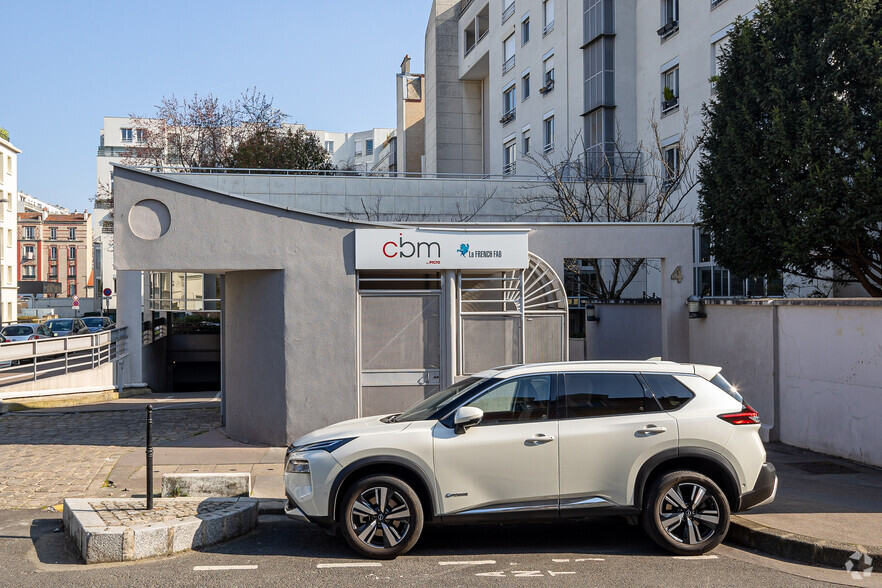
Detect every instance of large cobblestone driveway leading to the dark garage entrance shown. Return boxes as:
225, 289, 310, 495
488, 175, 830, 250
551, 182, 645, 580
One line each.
0, 408, 220, 509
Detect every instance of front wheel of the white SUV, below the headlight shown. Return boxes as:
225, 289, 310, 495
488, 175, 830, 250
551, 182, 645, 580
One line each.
339, 476, 423, 559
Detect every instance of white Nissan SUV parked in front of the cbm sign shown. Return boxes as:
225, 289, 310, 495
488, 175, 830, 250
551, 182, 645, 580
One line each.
285, 361, 778, 558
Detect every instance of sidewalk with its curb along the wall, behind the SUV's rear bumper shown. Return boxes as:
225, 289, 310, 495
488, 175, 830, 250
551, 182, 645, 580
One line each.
729, 443, 882, 567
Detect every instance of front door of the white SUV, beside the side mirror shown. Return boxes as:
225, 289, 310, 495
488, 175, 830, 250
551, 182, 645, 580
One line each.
433, 374, 559, 516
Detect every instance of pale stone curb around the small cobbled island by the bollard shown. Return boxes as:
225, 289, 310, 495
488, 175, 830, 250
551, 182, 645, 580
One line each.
63, 498, 258, 564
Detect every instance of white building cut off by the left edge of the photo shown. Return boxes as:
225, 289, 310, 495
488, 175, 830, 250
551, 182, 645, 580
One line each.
0, 127, 21, 323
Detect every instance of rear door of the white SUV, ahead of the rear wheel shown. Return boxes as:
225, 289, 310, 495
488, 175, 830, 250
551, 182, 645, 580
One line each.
558, 372, 678, 513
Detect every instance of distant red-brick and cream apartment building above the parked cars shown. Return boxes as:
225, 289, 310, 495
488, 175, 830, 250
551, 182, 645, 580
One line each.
18, 210, 94, 298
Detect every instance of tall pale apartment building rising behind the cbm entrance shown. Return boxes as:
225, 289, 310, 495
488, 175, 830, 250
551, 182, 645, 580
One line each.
425, 0, 764, 296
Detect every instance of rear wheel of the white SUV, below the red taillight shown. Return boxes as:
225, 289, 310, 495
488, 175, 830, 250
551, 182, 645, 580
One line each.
642, 470, 729, 555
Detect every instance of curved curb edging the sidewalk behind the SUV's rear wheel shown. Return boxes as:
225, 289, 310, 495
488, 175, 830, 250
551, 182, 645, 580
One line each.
728, 515, 882, 568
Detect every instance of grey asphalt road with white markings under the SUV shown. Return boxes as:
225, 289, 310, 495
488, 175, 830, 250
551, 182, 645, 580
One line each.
0, 511, 868, 588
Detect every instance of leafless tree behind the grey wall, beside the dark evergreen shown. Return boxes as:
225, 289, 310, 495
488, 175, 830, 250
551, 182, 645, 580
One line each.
515, 111, 701, 300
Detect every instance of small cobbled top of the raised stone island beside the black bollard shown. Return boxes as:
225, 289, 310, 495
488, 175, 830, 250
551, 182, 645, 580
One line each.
89, 498, 237, 527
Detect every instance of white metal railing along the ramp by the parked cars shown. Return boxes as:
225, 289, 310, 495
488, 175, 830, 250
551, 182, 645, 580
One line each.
0, 327, 126, 389
